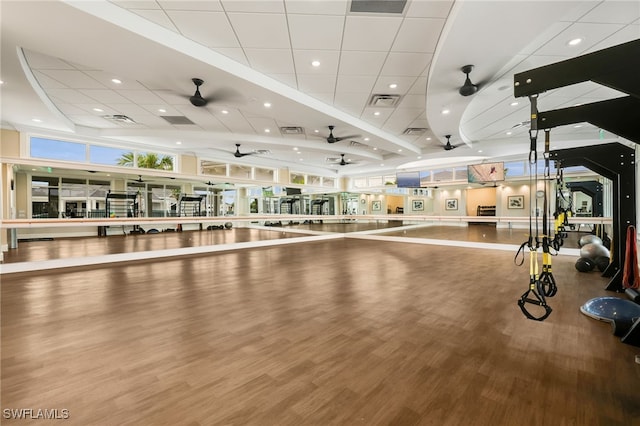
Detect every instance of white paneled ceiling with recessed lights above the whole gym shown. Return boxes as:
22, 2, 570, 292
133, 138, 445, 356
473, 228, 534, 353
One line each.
0, 0, 640, 176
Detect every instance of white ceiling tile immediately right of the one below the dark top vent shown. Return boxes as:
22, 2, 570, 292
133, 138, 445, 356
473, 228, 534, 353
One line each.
391, 18, 445, 53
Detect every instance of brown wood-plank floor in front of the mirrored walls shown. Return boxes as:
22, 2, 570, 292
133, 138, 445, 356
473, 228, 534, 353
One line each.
1, 239, 640, 426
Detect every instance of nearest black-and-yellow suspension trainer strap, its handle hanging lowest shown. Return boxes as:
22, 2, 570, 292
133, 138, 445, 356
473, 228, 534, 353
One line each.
516, 95, 551, 321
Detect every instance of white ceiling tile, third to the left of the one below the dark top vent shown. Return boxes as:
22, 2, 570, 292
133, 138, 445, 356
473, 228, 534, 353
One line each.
167, 10, 240, 48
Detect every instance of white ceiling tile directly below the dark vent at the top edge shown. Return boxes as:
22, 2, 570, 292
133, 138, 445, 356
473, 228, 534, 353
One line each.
342, 16, 402, 52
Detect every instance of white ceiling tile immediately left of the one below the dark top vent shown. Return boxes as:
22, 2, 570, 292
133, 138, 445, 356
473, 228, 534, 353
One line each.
288, 15, 344, 50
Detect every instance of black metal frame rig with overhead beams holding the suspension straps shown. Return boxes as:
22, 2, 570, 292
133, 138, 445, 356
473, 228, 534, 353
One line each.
513, 39, 640, 291
